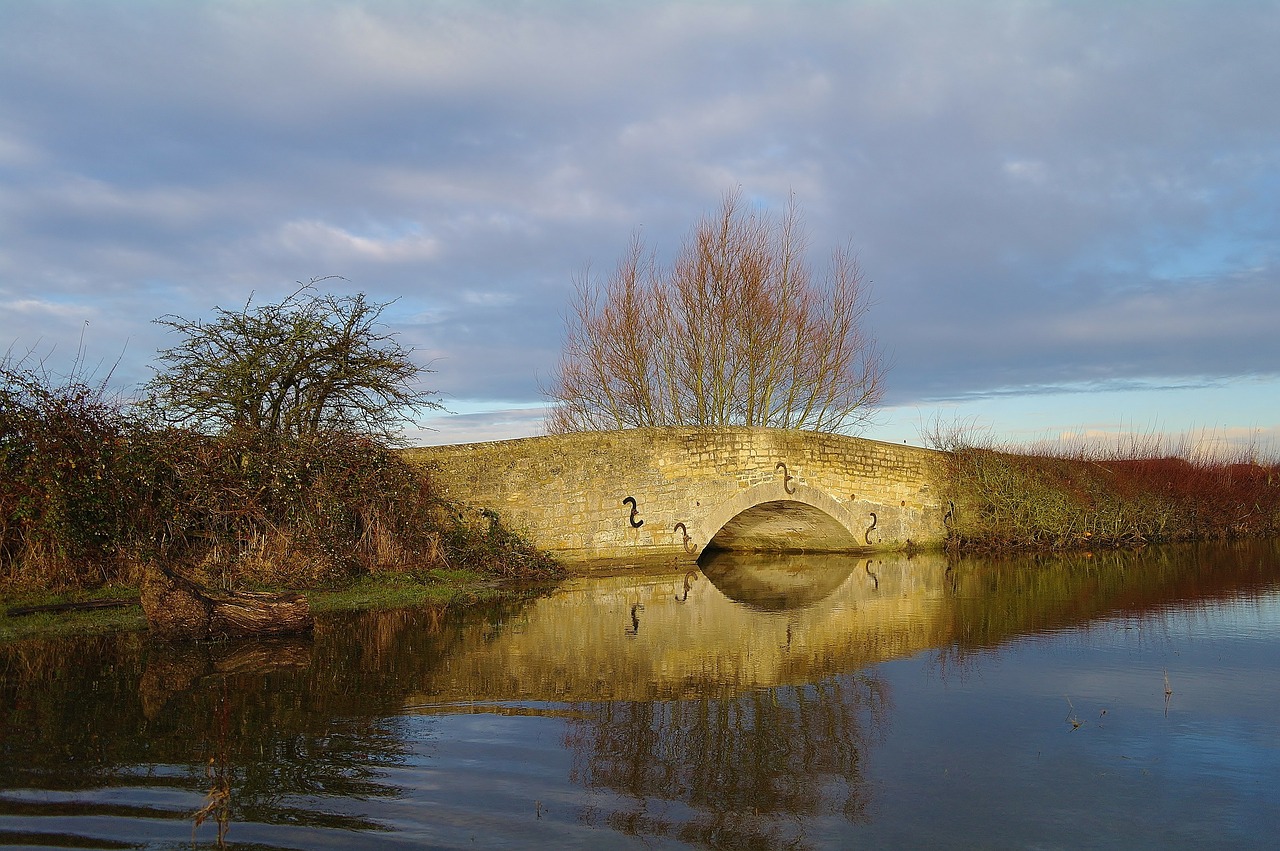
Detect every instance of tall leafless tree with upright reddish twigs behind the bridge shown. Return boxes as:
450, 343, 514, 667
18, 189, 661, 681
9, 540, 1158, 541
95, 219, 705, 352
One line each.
547, 192, 884, 434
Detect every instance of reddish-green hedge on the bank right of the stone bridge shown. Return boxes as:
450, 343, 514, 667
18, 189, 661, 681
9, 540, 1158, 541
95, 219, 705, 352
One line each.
933, 433, 1280, 550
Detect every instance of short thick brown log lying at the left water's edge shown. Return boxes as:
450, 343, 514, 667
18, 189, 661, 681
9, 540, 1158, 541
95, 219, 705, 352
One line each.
142, 567, 315, 640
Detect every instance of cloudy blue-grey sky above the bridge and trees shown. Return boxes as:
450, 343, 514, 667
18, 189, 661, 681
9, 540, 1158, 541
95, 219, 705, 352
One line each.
0, 0, 1280, 456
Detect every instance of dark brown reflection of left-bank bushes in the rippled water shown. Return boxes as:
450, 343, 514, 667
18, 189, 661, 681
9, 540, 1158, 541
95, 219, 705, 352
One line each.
0, 610, 463, 833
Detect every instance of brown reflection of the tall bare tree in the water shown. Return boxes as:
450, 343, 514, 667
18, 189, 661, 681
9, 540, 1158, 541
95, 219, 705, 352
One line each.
566, 674, 890, 847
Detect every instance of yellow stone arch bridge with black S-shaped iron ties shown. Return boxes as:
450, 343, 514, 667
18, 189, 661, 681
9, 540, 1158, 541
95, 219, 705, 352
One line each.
404, 427, 946, 562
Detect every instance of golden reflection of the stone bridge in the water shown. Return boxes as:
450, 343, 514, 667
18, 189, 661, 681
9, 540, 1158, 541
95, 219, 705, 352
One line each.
404, 553, 950, 712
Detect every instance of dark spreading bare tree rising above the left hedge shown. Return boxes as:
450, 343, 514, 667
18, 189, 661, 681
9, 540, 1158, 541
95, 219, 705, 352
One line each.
147, 279, 440, 439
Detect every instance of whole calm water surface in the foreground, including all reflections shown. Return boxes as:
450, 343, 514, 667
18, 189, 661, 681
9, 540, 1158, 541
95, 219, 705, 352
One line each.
0, 541, 1280, 848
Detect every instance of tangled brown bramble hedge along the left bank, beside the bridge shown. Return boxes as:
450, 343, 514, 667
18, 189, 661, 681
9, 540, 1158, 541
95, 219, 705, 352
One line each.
0, 363, 556, 589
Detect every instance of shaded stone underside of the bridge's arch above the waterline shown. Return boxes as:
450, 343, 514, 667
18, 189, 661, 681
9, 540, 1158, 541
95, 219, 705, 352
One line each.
705, 499, 860, 553
